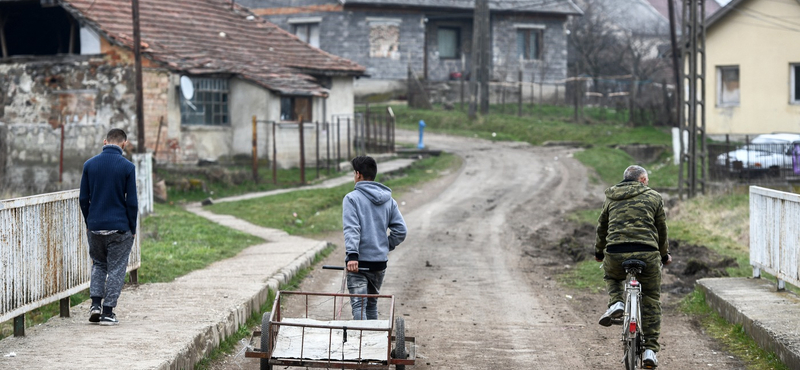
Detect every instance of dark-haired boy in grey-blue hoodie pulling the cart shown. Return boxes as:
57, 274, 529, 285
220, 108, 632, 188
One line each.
342, 156, 406, 320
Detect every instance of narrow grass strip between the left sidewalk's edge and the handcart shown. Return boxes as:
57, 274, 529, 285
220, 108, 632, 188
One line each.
195, 245, 336, 370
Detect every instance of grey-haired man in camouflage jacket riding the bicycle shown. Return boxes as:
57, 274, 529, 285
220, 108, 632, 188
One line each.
595, 165, 672, 368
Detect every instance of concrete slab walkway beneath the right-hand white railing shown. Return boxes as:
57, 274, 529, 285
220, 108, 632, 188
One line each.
697, 278, 800, 369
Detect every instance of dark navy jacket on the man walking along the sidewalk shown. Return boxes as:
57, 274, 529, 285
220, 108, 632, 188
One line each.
78, 145, 139, 233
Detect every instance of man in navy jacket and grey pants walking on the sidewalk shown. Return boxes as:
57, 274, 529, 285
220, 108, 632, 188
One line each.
79, 128, 139, 325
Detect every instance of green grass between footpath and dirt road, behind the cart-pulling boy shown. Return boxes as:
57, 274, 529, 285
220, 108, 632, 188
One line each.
209, 153, 461, 235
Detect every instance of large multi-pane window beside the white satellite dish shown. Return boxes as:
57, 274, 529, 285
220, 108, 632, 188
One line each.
180, 78, 229, 125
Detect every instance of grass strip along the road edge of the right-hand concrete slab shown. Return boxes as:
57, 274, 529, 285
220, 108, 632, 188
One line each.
680, 288, 789, 370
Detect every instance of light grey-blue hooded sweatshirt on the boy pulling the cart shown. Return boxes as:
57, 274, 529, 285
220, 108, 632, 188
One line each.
342, 181, 406, 271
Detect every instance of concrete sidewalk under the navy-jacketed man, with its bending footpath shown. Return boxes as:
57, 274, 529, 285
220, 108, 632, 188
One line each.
0, 159, 413, 370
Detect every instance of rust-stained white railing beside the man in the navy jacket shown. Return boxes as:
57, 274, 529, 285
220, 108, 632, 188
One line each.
0, 154, 153, 322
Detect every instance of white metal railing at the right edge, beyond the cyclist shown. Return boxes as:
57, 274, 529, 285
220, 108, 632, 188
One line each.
750, 186, 800, 290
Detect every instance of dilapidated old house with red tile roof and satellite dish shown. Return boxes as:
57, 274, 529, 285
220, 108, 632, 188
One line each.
0, 0, 365, 190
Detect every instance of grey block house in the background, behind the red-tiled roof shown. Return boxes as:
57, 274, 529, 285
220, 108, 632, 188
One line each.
237, 0, 581, 95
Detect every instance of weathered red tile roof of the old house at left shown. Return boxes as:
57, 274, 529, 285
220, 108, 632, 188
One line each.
63, 0, 365, 95
